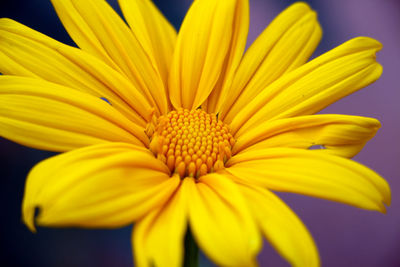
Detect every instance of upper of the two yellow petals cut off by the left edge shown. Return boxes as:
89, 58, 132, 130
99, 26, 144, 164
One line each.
0, 19, 151, 126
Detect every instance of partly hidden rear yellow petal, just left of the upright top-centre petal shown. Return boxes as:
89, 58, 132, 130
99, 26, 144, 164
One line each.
118, 0, 176, 84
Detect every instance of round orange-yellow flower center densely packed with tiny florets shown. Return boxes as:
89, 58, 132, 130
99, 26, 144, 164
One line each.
150, 109, 235, 178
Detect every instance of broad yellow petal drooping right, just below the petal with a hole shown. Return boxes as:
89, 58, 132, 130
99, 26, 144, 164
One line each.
227, 148, 390, 212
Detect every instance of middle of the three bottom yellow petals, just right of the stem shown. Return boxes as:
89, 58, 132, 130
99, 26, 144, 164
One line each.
185, 176, 261, 266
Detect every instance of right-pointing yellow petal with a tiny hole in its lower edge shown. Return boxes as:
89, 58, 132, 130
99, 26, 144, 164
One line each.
232, 115, 380, 158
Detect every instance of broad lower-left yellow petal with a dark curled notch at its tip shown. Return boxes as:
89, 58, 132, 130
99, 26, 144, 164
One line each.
23, 143, 180, 231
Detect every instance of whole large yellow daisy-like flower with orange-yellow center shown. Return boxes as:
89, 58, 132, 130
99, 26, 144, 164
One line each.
0, 0, 390, 267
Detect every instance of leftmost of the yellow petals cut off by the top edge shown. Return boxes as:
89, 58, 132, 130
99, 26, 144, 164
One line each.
51, 0, 169, 114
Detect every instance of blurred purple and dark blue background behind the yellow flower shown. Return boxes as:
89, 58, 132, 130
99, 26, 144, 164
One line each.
0, 0, 400, 267
